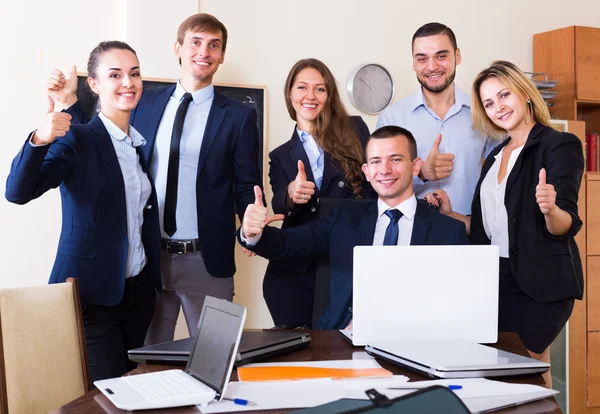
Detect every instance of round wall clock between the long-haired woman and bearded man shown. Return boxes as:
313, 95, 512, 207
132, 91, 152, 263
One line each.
348, 64, 394, 114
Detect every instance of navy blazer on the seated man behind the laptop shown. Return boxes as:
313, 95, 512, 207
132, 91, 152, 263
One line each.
243, 200, 469, 329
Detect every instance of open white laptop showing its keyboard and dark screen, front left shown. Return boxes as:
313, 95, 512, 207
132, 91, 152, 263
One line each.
94, 296, 246, 410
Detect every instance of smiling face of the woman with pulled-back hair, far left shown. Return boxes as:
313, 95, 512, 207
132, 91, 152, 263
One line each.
88, 49, 142, 118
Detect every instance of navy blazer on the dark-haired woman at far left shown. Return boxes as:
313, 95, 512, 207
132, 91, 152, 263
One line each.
6, 117, 162, 306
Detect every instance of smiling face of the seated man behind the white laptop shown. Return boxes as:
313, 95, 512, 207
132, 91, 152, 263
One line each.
362, 135, 422, 207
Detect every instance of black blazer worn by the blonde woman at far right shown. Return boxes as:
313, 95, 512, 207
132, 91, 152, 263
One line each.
471, 124, 584, 302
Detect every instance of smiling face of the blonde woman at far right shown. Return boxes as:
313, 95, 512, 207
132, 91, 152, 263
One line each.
479, 76, 532, 135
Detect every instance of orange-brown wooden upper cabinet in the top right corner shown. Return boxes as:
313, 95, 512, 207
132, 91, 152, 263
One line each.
533, 26, 600, 132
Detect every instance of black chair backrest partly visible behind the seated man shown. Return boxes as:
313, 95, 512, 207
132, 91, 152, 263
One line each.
312, 197, 373, 328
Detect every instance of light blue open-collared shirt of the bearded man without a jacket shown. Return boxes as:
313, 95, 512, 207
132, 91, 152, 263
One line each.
377, 84, 500, 214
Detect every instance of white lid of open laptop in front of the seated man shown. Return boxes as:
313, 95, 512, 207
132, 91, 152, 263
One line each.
352, 246, 499, 346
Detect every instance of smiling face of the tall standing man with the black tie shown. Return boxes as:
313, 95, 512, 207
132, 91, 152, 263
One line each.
175, 31, 225, 92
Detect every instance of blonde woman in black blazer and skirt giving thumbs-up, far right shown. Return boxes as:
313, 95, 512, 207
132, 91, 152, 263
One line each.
427, 61, 584, 372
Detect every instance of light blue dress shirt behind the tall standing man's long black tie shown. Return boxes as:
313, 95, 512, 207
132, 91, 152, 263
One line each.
150, 82, 215, 240
